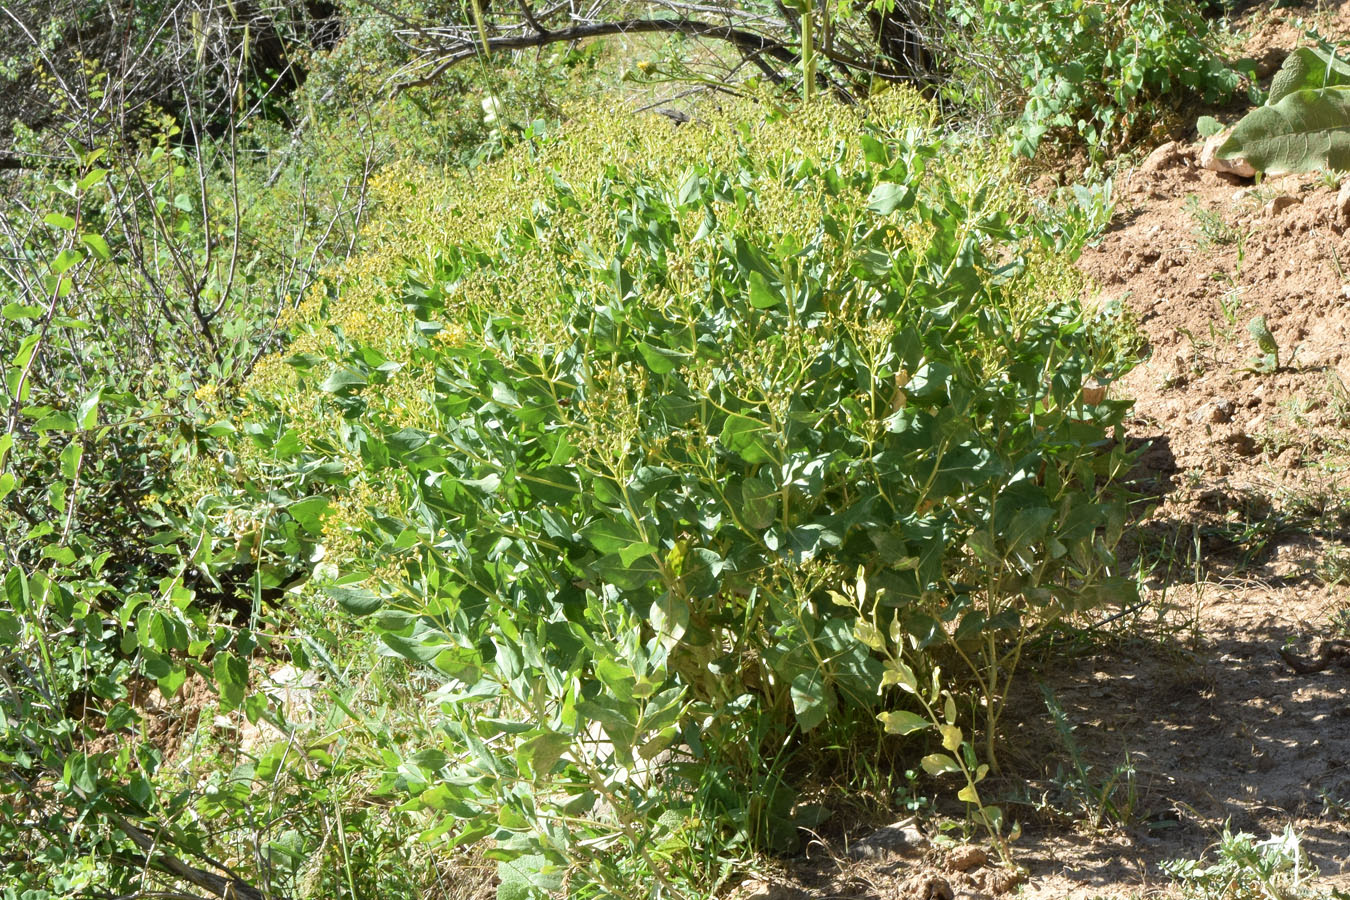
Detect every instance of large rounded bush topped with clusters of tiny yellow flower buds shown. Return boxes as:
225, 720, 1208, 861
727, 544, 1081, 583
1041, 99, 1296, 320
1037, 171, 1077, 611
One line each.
218, 92, 1129, 896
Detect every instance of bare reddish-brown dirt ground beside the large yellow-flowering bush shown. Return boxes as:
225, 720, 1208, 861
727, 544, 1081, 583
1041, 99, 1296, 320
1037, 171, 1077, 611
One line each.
740, 3, 1350, 900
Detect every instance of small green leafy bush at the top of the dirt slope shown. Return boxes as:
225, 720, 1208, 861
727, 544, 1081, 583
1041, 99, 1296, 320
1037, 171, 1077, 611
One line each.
949, 0, 1242, 161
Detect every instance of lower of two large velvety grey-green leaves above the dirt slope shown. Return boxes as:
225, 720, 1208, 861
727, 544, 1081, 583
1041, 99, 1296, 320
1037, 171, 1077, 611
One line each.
1219, 86, 1350, 175
